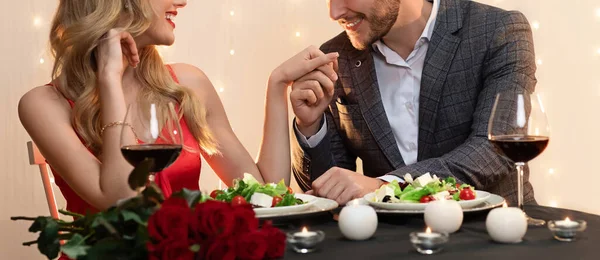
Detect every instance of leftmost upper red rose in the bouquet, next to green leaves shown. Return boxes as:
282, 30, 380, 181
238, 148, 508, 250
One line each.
148, 197, 191, 244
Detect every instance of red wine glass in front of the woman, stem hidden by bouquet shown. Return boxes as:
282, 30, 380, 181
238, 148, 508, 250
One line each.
121, 102, 183, 183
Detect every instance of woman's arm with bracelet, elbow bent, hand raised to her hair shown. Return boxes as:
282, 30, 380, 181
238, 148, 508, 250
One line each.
19, 29, 139, 210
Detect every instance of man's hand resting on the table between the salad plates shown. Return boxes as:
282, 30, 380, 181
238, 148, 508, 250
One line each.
309, 167, 384, 205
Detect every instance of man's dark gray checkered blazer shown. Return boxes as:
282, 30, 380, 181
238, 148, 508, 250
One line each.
292, 0, 536, 205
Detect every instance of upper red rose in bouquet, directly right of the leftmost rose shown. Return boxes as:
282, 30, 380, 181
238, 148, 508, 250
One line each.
194, 200, 235, 242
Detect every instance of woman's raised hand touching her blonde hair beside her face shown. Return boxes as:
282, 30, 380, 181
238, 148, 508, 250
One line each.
96, 29, 140, 80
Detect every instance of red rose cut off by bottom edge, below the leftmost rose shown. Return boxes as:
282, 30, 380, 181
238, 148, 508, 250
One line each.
147, 238, 195, 260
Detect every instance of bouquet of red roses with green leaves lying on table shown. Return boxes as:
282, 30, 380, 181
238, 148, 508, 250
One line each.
12, 159, 286, 260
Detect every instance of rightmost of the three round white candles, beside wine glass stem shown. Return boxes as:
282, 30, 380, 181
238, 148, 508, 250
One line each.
485, 203, 527, 243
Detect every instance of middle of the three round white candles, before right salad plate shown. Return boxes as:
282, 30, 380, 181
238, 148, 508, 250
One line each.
424, 200, 463, 233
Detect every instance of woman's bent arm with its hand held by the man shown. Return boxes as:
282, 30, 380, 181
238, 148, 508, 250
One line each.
172, 47, 337, 185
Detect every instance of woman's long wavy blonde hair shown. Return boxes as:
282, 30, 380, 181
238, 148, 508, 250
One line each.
50, 0, 217, 155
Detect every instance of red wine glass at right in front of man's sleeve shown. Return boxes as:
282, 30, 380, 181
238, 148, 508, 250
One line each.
488, 91, 550, 226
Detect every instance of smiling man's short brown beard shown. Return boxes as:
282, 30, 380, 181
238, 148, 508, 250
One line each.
348, 0, 400, 50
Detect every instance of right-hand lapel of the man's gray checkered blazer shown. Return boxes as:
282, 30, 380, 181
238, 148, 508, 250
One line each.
417, 0, 462, 161
